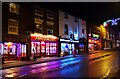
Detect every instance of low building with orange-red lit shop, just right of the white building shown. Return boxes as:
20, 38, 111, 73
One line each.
87, 23, 101, 51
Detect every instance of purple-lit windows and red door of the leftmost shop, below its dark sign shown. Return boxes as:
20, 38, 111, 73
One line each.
2, 42, 26, 60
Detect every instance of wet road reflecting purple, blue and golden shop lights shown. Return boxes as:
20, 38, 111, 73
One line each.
1, 49, 120, 79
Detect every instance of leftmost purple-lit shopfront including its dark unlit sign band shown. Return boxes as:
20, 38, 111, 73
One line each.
0, 35, 28, 61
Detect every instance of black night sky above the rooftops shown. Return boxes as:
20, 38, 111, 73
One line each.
34, 2, 120, 25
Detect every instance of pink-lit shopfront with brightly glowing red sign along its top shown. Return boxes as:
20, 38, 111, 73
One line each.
31, 34, 58, 57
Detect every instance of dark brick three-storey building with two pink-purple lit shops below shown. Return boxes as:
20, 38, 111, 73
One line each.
0, 2, 59, 60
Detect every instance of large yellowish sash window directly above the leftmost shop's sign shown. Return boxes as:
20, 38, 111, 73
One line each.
8, 19, 18, 34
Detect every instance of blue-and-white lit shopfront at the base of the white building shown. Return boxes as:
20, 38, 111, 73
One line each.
60, 39, 79, 56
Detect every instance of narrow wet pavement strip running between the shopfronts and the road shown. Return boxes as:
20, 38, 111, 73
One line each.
0, 50, 115, 70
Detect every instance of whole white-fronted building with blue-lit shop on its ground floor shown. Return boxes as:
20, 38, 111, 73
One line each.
59, 10, 87, 55
